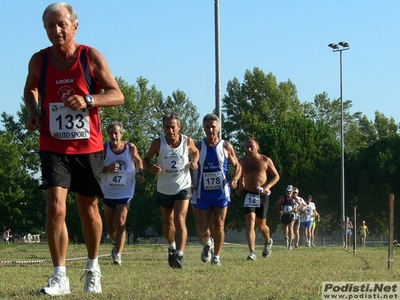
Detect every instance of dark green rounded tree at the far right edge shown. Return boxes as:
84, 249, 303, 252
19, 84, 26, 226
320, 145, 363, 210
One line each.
346, 135, 400, 234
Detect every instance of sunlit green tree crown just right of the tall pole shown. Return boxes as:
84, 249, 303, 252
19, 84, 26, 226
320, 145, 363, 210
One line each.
223, 67, 302, 145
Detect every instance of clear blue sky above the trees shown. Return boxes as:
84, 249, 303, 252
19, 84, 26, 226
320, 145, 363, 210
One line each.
0, 0, 400, 126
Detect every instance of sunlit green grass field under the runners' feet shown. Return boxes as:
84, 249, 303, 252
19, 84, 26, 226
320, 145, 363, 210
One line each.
0, 244, 400, 299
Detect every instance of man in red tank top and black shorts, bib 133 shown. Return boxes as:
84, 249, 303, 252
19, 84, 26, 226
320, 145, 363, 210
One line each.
24, 2, 124, 298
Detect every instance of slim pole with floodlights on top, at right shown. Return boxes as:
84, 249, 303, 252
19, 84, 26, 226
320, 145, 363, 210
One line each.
328, 42, 350, 247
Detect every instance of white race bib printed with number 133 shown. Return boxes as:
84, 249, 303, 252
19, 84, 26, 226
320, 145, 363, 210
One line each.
49, 102, 90, 140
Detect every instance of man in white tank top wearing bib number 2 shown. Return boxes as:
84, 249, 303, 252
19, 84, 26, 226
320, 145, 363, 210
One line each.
143, 112, 199, 269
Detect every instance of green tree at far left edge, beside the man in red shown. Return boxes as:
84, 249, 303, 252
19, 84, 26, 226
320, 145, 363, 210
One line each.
0, 108, 45, 234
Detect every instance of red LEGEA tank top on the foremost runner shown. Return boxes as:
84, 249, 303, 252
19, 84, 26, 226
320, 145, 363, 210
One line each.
38, 45, 104, 154
